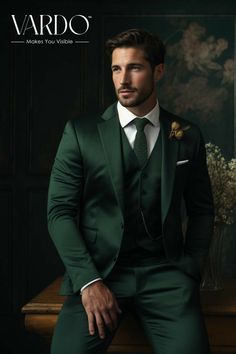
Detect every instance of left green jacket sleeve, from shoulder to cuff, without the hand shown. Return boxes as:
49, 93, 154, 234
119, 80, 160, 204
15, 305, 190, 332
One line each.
48, 121, 100, 292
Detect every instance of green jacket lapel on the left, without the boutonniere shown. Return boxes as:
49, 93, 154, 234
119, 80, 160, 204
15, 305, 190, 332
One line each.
98, 104, 124, 211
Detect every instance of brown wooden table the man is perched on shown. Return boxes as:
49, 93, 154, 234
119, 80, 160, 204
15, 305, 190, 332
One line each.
22, 278, 236, 354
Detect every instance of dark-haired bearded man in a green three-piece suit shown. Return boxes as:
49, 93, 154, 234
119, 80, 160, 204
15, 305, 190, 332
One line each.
48, 29, 214, 354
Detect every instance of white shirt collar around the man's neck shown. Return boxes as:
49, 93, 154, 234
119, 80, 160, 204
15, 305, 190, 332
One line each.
117, 100, 160, 128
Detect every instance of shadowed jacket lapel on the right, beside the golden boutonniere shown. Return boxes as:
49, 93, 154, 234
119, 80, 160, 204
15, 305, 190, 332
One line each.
160, 108, 179, 224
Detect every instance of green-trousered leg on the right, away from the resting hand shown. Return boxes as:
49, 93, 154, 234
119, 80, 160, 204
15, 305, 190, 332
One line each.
135, 264, 209, 354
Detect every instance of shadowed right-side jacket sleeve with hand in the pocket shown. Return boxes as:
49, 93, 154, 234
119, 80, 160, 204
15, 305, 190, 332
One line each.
184, 128, 214, 271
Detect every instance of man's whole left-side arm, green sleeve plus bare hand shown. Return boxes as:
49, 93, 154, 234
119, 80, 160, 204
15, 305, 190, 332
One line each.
48, 121, 121, 338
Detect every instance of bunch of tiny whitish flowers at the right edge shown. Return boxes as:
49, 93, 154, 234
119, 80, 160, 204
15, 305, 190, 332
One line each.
205, 143, 236, 225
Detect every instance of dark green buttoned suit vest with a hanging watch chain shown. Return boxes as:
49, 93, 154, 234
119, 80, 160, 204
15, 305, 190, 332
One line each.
118, 123, 164, 264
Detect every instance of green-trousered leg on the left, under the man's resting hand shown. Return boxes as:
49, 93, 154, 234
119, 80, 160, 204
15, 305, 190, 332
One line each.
51, 267, 136, 354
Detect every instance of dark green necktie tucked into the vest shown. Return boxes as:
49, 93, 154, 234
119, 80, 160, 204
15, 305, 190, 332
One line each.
132, 118, 149, 167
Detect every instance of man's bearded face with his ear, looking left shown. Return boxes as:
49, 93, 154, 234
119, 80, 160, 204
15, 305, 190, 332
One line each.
111, 47, 163, 107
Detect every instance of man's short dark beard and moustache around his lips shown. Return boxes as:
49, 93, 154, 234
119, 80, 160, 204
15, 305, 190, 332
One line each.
116, 83, 154, 107
